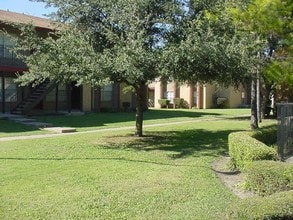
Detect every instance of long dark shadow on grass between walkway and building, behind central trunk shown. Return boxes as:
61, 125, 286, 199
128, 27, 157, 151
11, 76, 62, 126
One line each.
35, 109, 220, 128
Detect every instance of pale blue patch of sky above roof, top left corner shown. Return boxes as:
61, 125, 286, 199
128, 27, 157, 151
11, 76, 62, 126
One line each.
0, 0, 53, 17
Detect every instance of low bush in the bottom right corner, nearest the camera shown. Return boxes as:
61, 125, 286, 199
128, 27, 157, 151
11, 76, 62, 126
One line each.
226, 190, 293, 220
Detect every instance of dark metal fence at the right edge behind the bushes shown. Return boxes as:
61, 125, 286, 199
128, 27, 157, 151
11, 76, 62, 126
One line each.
277, 103, 293, 159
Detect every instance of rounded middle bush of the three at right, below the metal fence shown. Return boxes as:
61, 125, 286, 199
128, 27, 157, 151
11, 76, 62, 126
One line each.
244, 161, 293, 196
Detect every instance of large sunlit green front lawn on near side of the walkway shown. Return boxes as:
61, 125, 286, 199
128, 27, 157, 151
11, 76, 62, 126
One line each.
0, 111, 275, 219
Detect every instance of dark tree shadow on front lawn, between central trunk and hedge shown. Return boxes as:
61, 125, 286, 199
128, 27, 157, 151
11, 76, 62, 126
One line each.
100, 129, 244, 159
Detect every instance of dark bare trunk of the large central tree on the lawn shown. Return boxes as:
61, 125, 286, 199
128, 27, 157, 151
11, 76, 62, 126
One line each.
135, 83, 146, 137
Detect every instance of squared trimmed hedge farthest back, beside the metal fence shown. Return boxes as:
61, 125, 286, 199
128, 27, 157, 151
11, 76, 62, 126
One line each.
228, 132, 278, 170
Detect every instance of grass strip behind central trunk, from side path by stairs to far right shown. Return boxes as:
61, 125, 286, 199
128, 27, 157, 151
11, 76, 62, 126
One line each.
31, 109, 249, 131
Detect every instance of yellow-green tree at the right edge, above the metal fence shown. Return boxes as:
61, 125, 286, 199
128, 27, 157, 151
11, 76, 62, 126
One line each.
231, 0, 293, 125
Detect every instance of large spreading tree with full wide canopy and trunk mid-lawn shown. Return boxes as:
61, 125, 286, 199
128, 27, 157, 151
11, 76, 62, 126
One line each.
16, 0, 256, 136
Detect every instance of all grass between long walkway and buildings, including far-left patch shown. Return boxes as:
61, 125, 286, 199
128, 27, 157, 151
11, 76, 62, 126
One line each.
0, 109, 249, 137
